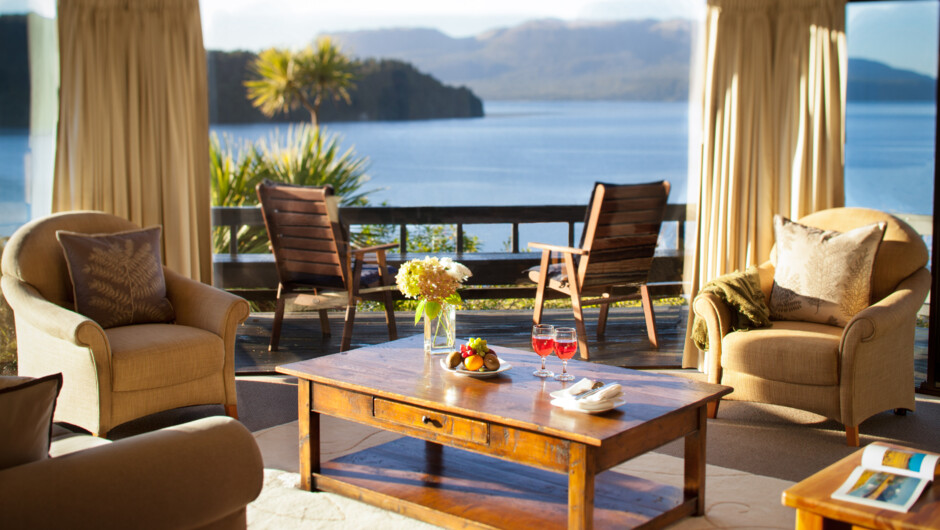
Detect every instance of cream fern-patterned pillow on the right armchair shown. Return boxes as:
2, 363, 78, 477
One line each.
770, 215, 887, 326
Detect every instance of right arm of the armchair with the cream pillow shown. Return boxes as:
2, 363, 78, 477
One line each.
839, 268, 931, 425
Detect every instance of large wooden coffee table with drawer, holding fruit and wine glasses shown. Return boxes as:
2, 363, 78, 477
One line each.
277, 336, 731, 529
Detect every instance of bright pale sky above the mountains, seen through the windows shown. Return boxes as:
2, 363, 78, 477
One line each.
0, 0, 940, 76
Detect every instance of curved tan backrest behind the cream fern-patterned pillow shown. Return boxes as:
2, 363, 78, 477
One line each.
799, 208, 929, 306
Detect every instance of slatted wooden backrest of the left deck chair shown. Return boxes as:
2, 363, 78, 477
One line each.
256, 181, 348, 289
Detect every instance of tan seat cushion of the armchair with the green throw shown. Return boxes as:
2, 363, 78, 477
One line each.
721, 320, 842, 385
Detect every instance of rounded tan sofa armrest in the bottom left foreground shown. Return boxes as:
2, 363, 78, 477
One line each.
0, 416, 263, 528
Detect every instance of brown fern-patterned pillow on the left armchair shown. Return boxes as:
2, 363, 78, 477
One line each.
56, 223, 175, 328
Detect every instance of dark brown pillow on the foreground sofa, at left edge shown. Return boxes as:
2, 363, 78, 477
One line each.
0, 374, 62, 469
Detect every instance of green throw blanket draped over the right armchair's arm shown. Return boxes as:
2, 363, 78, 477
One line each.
692, 267, 770, 350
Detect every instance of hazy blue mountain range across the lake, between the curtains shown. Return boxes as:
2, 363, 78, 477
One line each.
330, 20, 692, 100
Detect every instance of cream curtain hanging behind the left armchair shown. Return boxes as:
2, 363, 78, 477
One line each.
53, 0, 212, 283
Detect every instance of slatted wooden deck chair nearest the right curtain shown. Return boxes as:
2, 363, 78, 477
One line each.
529, 181, 669, 359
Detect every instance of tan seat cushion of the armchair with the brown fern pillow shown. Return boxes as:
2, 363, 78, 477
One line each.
106, 324, 225, 392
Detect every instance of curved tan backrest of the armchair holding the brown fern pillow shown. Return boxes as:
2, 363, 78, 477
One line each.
2, 211, 140, 309
